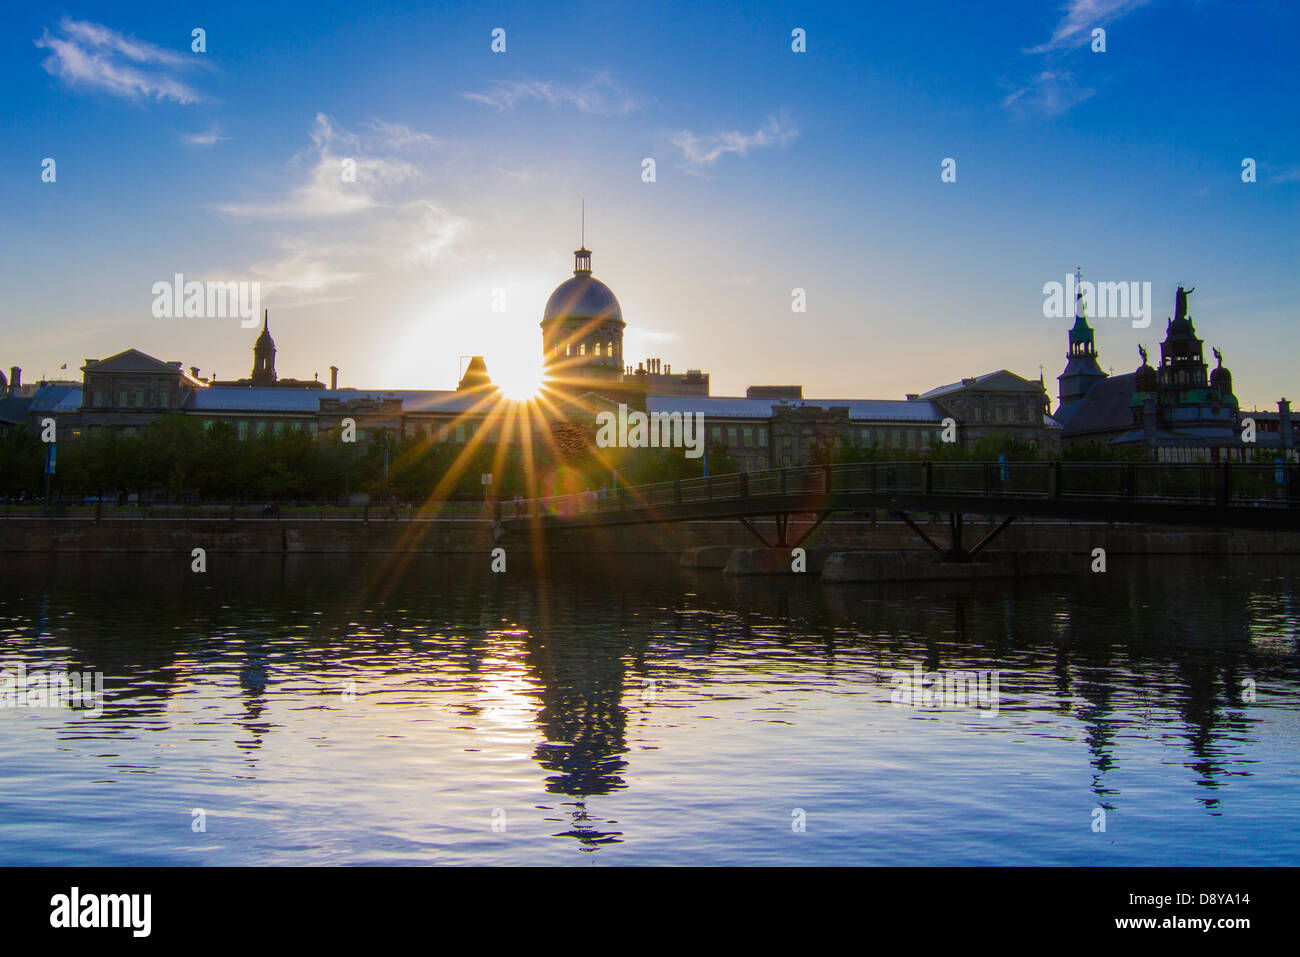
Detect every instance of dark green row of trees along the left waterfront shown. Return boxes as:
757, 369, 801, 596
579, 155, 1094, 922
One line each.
0, 412, 738, 503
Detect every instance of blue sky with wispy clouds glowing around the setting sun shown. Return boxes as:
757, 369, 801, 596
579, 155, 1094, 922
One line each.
0, 0, 1300, 407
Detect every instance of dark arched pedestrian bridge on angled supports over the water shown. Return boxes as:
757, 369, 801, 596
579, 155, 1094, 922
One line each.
495, 462, 1300, 558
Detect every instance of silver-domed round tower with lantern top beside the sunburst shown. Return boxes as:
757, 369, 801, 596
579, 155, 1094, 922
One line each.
541, 246, 627, 382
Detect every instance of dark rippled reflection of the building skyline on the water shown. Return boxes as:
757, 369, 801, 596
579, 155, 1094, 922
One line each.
0, 546, 1300, 850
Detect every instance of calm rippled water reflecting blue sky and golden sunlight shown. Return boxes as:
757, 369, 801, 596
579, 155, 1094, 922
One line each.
0, 546, 1300, 865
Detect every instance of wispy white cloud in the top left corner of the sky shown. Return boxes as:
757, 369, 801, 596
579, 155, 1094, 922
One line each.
36, 17, 203, 104
